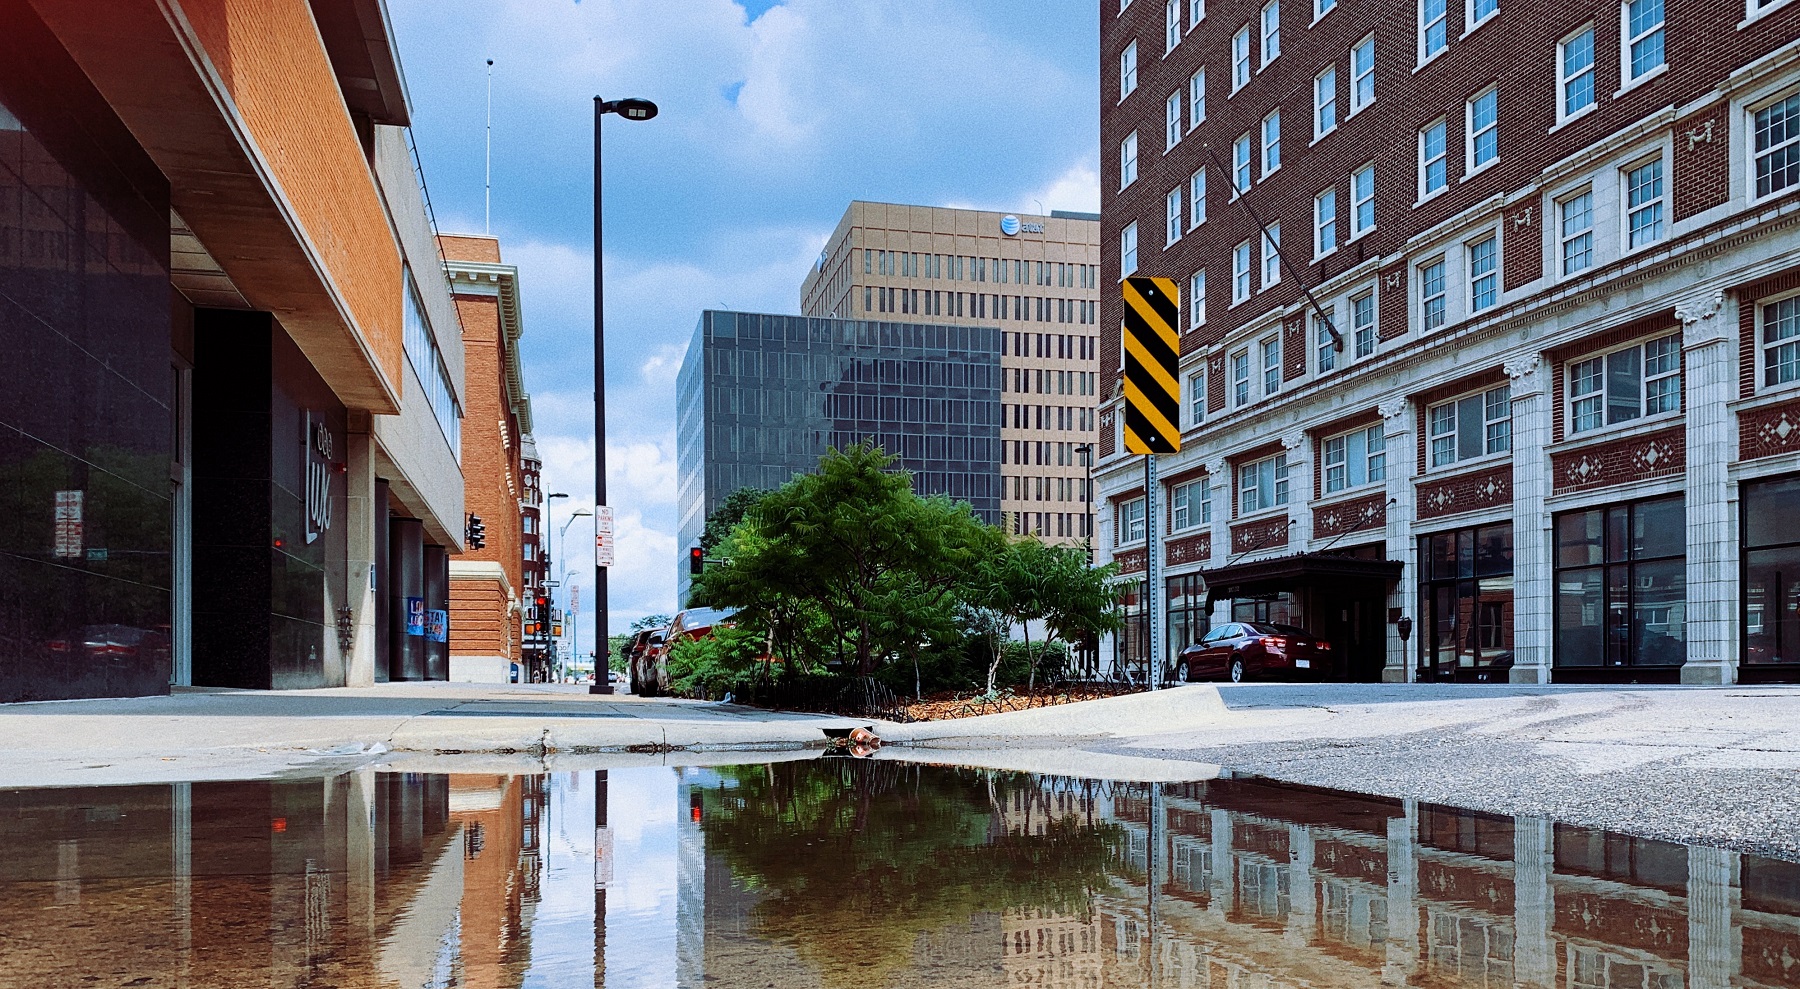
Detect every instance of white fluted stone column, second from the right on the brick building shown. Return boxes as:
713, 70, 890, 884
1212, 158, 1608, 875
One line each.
1505, 353, 1555, 683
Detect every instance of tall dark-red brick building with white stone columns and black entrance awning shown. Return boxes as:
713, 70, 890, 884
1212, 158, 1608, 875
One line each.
1098, 0, 1800, 683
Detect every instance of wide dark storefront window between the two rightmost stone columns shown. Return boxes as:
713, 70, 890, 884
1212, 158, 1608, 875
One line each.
1555, 495, 1687, 668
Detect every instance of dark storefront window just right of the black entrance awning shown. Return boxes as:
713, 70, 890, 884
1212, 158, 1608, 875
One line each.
1418, 522, 1512, 679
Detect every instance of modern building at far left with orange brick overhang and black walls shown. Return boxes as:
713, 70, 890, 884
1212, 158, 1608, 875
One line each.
0, 0, 463, 701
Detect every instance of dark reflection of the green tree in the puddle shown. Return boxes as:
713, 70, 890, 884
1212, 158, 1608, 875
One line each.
700, 760, 1120, 987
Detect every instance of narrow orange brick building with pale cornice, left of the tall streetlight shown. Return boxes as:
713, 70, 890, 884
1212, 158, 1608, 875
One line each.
439, 234, 531, 683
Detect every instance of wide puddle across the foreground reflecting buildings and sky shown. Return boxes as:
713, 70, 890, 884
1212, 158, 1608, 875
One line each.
0, 760, 1800, 989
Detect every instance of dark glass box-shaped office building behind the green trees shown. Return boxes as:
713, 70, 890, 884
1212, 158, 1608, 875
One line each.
675, 310, 1001, 602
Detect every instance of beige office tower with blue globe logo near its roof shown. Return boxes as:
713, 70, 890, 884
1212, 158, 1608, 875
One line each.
801, 202, 1100, 542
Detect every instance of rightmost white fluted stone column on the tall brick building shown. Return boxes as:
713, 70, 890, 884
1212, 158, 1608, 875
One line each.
1676, 292, 1739, 683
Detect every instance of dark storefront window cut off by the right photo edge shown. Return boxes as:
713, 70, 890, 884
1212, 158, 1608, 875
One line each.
1742, 476, 1800, 667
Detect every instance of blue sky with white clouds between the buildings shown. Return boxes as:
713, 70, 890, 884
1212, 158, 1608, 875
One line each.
391, 0, 1100, 649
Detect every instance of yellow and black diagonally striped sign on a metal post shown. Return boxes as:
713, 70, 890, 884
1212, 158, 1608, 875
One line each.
1121, 277, 1181, 454
